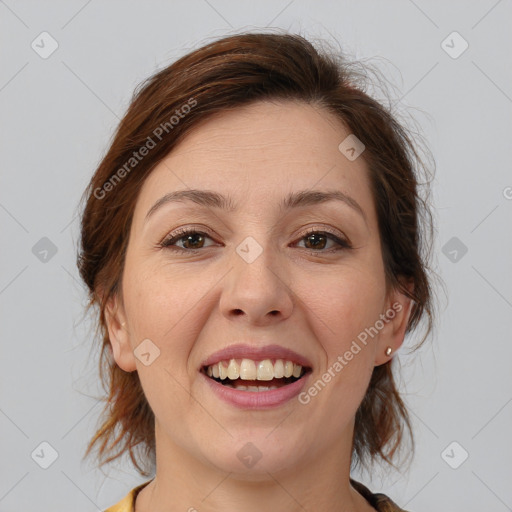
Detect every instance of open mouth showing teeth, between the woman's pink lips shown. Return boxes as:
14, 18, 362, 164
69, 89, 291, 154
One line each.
201, 359, 311, 392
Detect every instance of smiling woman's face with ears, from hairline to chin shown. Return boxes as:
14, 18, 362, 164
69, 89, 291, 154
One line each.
108, 102, 408, 478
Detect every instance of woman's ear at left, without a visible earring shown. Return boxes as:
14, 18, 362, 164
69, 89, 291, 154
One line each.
105, 295, 136, 372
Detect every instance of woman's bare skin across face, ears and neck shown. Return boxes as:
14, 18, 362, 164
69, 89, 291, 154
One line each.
107, 102, 411, 512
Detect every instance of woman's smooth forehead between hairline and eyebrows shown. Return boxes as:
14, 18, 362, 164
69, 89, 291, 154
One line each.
132, 101, 374, 221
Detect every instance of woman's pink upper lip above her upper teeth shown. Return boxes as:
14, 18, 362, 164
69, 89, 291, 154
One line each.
200, 344, 311, 369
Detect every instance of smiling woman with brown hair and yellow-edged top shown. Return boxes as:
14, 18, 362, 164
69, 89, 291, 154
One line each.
79, 30, 432, 512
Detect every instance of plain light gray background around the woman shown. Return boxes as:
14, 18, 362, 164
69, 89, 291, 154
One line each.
0, 0, 512, 512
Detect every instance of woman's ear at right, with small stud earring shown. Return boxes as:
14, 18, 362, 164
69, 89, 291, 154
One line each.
375, 280, 414, 366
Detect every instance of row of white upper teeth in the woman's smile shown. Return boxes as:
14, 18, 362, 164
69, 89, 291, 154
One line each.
206, 359, 302, 380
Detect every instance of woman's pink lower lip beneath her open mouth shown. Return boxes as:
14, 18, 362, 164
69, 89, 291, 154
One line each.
201, 372, 311, 409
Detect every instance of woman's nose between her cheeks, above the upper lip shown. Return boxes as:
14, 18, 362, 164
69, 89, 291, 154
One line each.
220, 240, 294, 326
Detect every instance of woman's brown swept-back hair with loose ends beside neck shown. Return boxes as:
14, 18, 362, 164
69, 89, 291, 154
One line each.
78, 33, 433, 476
